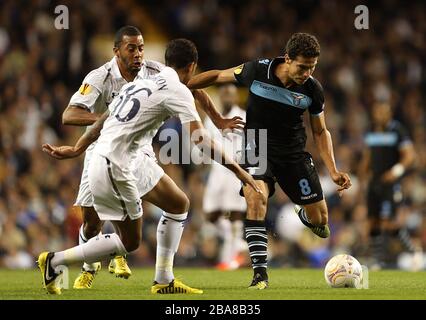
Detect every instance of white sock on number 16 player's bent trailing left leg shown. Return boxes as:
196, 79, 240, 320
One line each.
51, 233, 127, 268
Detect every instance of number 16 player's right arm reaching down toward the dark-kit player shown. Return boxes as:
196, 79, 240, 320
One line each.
186, 121, 262, 193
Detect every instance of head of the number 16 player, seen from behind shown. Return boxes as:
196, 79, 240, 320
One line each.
164, 39, 198, 84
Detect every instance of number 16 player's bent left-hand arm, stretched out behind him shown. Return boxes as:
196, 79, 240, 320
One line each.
42, 111, 109, 160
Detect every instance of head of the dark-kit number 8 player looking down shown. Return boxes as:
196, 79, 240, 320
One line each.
284, 33, 320, 85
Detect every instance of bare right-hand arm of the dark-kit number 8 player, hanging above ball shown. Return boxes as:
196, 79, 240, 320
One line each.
310, 113, 352, 193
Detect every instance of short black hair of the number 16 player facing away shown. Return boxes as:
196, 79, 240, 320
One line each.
164, 39, 198, 69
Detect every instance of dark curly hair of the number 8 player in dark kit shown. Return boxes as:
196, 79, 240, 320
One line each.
285, 32, 320, 59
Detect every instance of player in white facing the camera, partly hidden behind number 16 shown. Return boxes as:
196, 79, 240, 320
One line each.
62, 26, 245, 289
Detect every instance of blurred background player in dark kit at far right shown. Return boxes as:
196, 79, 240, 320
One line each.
359, 102, 415, 268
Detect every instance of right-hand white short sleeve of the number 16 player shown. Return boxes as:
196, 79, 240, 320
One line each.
164, 85, 201, 123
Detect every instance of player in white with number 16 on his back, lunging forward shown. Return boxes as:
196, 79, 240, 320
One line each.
38, 39, 260, 294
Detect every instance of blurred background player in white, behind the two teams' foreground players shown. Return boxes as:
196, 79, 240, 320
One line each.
203, 83, 247, 270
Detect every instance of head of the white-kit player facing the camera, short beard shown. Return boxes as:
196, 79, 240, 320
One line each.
114, 26, 144, 77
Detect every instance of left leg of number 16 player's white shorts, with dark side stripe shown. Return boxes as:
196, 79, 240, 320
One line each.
88, 154, 143, 221
